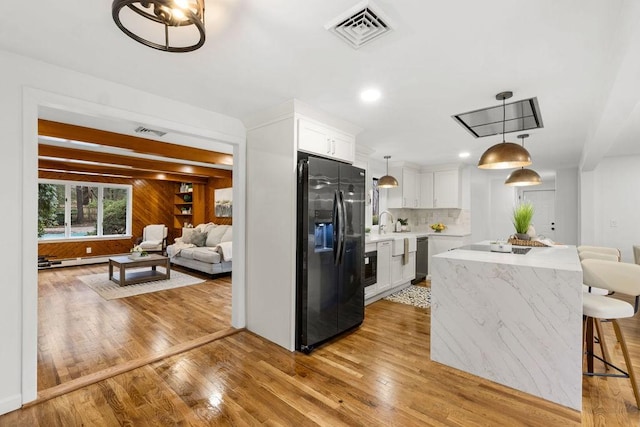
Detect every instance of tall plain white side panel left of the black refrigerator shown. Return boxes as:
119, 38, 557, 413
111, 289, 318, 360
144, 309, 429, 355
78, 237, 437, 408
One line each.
246, 112, 297, 350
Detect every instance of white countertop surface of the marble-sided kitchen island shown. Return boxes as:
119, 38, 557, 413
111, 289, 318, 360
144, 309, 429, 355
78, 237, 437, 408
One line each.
434, 241, 582, 271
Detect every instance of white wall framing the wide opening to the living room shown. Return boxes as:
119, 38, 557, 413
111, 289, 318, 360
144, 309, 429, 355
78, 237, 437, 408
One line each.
0, 51, 245, 414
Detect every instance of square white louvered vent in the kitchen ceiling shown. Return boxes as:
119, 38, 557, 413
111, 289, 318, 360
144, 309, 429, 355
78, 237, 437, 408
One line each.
324, 1, 392, 49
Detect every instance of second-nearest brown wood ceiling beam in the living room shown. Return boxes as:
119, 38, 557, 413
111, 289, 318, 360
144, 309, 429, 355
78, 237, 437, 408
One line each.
38, 144, 232, 178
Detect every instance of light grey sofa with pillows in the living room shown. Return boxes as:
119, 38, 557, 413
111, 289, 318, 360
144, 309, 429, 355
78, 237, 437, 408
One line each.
167, 223, 233, 274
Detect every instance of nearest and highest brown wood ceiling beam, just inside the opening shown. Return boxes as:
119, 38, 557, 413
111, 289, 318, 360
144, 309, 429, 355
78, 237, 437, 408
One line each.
38, 119, 233, 166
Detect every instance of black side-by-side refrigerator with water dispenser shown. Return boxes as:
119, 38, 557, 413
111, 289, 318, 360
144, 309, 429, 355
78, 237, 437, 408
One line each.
296, 153, 365, 353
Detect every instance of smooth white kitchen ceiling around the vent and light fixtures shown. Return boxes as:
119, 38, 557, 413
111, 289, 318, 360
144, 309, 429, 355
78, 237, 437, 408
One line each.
5, 0, 640, 172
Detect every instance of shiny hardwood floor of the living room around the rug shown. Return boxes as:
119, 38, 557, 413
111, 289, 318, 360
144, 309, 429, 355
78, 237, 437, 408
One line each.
38, 264, 231, 390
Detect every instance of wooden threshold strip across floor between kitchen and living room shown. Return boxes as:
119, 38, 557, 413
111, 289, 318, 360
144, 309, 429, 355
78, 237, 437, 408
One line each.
23, 328, 246, 408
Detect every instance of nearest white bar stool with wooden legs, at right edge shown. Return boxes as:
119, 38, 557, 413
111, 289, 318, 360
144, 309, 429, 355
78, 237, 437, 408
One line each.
582, 259, 640, 409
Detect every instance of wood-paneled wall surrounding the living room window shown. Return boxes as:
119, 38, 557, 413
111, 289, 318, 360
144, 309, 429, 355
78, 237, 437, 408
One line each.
38, 171, 179, 259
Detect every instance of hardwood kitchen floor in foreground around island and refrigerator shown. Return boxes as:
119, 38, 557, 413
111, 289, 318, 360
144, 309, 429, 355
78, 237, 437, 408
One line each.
0, 272, 640, 426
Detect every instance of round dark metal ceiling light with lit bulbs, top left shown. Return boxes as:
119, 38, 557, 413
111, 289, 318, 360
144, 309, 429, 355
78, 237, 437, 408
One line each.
111, 0, 205, 52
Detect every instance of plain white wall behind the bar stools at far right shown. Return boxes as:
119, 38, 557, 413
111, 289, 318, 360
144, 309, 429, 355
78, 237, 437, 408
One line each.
581, 156, 640, 262
